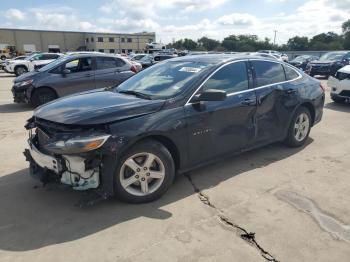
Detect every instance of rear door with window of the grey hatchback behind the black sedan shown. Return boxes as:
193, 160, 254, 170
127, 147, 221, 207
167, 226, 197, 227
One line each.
95, 56, 133, 88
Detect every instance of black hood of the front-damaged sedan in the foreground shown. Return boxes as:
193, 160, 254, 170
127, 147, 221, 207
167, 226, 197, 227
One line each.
34, 90, 165, 125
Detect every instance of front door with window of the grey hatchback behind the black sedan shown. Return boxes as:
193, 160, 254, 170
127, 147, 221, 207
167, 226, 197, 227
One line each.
47, 57, 95, 96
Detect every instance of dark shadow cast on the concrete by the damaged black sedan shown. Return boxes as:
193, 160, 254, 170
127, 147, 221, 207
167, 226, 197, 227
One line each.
0, 138, 313, 251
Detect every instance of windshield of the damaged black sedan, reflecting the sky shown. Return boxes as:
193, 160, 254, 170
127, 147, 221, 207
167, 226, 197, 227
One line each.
115, 61, 212, 98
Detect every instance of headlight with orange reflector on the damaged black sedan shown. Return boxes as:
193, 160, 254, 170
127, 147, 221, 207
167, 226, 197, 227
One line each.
44, 134, 110, 154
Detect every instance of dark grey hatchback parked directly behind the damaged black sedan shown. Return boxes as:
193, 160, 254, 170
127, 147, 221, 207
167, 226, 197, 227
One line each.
12, 54, 136, 107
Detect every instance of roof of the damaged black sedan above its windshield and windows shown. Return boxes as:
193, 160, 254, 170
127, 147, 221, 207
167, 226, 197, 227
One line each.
167, 54, 280, 64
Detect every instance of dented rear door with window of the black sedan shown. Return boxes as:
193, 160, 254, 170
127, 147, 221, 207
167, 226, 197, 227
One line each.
251, 60, 301, 143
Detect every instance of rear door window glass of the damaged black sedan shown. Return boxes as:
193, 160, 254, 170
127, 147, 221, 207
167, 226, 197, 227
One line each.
252, 61, 286, 87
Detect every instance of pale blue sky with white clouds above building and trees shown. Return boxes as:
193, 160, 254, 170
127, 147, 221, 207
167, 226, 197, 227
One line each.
0, 0, 350, 44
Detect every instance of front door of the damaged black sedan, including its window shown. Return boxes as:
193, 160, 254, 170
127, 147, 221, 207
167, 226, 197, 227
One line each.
185, 61, 256, 164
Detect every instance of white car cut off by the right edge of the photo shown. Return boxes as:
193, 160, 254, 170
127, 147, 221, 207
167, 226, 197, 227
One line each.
327, 65, 350, 103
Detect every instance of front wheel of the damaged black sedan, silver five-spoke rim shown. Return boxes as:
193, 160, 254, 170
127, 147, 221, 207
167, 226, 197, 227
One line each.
114, 140, 175, 203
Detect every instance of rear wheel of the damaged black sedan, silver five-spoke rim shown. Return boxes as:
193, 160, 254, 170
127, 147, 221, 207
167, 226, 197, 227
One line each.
285, 106, 312, 147
